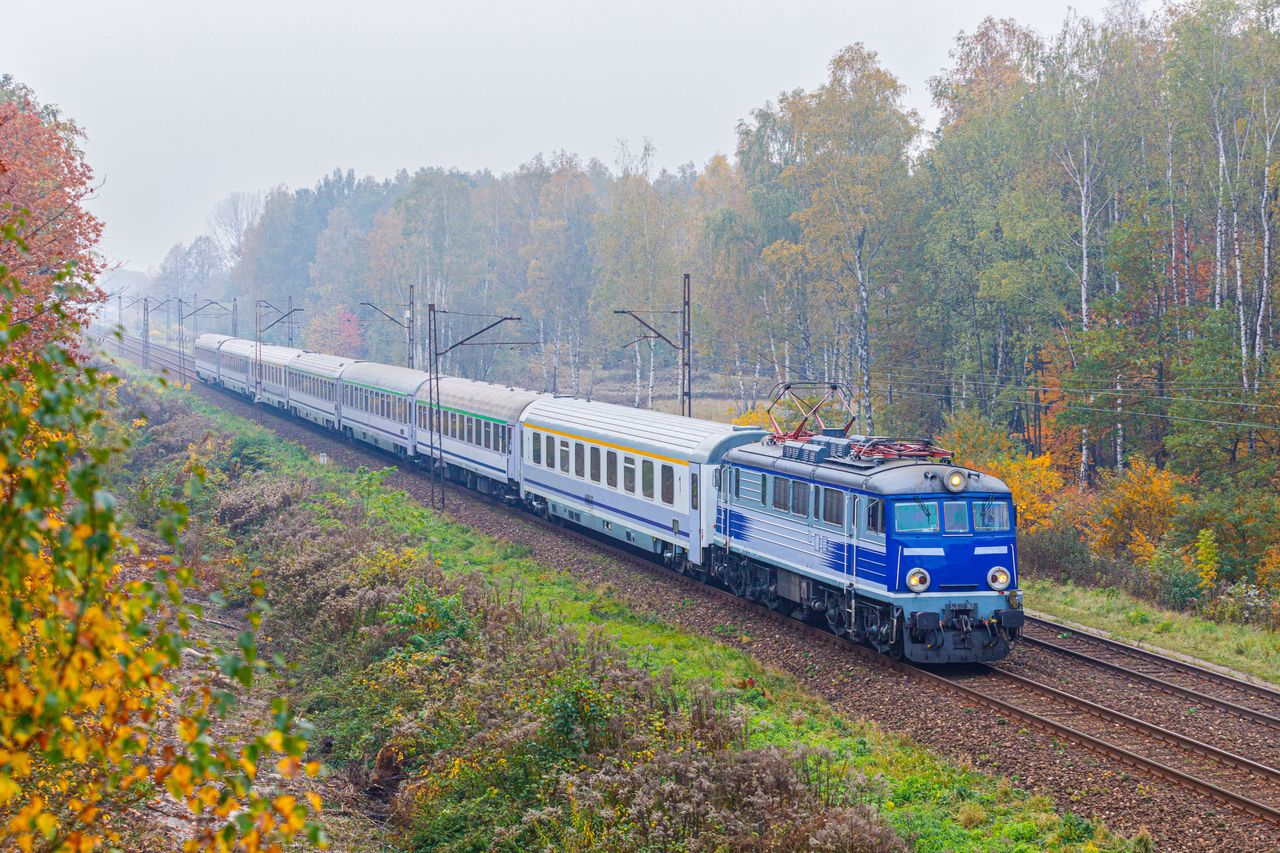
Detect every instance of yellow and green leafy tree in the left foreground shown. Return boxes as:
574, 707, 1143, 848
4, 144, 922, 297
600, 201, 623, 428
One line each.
0, 222, 320, 852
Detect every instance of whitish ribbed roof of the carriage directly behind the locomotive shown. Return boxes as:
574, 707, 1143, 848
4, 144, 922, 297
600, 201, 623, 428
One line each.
521, 396, 764, 462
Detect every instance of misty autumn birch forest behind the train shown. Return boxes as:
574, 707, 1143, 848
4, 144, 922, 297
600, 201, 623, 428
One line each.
142, 0, 1280, 617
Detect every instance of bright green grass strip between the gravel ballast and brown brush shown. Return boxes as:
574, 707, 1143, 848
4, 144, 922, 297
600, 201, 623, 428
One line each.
170, 389, 1130, 853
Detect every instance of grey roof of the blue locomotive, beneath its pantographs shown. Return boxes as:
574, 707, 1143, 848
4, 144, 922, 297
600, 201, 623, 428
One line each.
724, 442, 1010, 497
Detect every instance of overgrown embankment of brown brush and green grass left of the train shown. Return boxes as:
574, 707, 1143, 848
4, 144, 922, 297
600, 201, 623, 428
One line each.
102, 368, 1162, 850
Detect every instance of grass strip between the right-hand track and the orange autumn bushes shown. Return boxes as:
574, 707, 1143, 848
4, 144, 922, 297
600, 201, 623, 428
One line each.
1023, 580, 1280, 684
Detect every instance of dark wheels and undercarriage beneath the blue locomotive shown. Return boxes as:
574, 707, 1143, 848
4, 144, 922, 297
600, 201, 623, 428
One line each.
708, 548, 1023, 663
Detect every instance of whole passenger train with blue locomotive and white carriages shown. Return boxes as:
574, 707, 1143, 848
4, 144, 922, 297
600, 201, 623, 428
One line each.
195, 334, 1024, 663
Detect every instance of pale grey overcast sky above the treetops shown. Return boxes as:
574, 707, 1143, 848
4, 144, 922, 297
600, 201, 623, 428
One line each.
0, 0, 1106, 269
